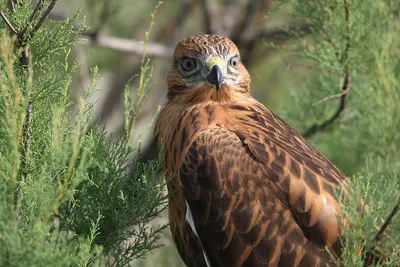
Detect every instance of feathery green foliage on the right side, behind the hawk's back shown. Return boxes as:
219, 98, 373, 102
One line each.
280, 0, 400, 266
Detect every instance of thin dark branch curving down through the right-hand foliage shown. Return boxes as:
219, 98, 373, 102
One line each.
303, 0, 350, 137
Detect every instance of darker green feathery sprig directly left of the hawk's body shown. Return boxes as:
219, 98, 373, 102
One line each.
60, 128, 165, 266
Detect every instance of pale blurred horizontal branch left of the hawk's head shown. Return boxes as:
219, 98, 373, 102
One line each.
82, 33, 174, 58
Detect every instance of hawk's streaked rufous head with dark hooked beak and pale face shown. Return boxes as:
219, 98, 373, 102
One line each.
168, 34, 250, 103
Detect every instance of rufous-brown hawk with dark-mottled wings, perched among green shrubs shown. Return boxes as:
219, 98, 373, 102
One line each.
155, 34, 348, 267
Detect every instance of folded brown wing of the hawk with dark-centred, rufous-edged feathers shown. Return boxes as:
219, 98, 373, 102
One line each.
179, 126, 344, 266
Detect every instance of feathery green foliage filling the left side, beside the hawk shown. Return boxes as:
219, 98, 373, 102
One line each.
0, 1, 166, 266
